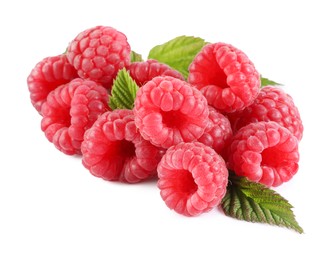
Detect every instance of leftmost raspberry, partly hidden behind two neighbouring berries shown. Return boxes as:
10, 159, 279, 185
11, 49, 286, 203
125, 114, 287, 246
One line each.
27, 54, 78, 113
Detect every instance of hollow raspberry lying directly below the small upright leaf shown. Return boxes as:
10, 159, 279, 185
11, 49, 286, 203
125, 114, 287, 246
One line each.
82, 109, 163, 183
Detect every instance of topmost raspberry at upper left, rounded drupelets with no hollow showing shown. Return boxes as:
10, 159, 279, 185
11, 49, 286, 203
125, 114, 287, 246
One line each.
67, 26, 131, 88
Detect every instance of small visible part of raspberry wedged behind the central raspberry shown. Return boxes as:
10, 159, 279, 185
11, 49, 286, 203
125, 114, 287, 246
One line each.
198, 106, 232, 153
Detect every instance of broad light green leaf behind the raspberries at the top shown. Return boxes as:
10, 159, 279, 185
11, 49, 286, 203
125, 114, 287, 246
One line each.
148, 36, 206, 78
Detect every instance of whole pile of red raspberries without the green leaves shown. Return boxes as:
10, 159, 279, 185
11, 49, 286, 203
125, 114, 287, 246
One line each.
27, 26, 303, 216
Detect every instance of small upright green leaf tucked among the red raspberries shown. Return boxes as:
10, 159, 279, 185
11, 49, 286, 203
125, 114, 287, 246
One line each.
109, 68, 139, 109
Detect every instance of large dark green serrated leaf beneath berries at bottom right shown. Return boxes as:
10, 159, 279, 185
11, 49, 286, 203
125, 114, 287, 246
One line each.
221, 172, 303, 233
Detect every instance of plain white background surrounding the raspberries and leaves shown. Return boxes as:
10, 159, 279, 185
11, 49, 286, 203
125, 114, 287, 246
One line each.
0, 0, 336, 260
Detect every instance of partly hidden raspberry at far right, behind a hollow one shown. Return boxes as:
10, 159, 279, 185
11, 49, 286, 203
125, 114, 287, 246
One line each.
228, 86, 303, 141
